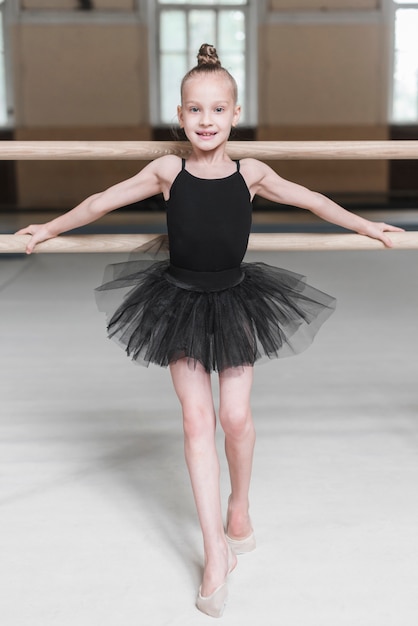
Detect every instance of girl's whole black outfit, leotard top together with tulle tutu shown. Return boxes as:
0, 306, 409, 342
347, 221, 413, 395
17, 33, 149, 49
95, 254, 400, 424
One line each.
99, 161, 335, 372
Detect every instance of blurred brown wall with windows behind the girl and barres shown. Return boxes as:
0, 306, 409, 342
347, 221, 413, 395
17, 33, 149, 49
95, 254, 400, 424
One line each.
0, 0, 418, 223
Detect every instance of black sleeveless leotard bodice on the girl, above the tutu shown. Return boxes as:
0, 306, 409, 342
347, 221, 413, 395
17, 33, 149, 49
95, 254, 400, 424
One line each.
167, 159, 252, 290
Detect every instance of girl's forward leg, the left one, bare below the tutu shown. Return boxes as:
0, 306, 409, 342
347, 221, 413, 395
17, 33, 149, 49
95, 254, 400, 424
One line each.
170, 359, 236, 596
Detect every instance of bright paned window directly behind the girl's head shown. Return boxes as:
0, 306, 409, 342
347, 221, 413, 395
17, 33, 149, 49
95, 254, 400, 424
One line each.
155, 0, 250, 125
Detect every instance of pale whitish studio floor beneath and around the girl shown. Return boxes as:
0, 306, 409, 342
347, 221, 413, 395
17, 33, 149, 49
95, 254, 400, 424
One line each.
0, 250, 418, 626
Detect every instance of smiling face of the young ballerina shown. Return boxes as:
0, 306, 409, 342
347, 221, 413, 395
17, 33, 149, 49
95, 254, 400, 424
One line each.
177, 73, 240, 151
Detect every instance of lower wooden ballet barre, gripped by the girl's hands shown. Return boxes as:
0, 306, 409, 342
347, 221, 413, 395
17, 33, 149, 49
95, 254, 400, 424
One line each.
0, 231, 418, 254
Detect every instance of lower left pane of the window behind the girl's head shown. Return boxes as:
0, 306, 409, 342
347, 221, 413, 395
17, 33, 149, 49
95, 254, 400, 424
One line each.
160, 54, 188, 124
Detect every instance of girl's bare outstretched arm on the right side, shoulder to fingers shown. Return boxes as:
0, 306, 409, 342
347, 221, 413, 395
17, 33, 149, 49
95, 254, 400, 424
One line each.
248, 159, 403, 248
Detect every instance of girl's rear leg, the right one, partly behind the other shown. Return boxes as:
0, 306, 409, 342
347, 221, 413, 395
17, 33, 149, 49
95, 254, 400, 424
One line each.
219, 366, 255, 539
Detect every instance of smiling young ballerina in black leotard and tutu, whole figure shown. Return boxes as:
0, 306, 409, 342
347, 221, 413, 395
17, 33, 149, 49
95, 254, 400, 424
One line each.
17, 44, 401, 617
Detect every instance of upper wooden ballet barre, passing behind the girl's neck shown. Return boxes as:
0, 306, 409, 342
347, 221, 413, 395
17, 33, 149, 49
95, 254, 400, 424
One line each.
0, 141, 418, 161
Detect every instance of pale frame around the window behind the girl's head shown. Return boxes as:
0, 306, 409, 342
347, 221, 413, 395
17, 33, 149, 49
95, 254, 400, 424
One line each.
147, 0, 257, 128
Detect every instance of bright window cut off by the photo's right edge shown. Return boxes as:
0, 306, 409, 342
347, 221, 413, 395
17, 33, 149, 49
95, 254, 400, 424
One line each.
392, 0, 418, 124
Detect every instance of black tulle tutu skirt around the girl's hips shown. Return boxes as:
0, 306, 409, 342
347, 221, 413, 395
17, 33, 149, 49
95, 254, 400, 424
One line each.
96, 239, 335, 372
